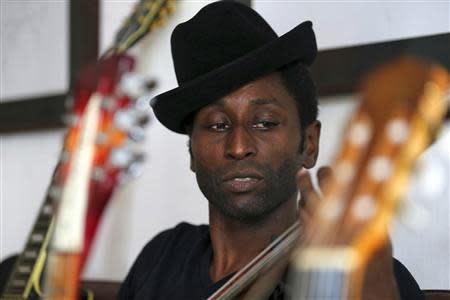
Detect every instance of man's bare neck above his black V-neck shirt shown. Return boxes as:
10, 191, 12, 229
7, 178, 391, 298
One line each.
209, 199, 298, 282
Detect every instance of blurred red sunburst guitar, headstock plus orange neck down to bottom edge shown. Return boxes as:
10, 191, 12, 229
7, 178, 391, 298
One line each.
44, 55, 148, 299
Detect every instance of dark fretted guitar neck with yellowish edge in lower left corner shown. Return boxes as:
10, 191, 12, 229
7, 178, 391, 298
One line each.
0, 190, 54, 300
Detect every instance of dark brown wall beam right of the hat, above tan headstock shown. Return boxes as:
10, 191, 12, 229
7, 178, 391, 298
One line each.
311, 33, 450, 96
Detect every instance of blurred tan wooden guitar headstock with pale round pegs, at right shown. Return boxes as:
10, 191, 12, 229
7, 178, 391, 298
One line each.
295, 57, 450, 278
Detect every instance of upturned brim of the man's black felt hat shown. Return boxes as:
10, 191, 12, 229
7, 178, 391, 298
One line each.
150, 21, 317, 134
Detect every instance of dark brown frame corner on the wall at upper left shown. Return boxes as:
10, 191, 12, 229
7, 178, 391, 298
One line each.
0, 0, 100, 133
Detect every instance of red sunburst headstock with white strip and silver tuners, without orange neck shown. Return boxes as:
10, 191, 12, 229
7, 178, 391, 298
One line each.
53, 55, 148, 264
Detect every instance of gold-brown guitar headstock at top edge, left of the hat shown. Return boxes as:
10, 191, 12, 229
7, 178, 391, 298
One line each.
110, 0, 175, 53
